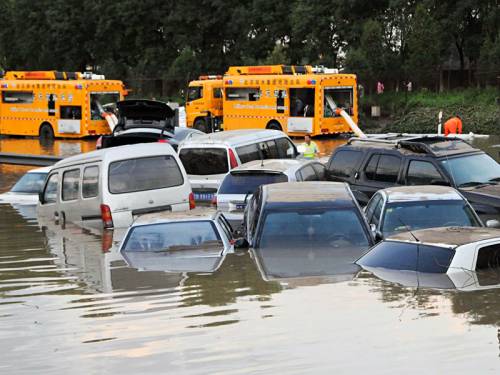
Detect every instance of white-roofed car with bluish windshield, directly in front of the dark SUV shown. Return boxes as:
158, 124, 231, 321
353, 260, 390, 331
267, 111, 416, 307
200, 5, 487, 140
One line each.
365, 185, 492, 239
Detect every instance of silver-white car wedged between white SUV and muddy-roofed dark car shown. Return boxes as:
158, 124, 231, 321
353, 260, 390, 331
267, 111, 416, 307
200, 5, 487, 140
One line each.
215, 159, 325, 228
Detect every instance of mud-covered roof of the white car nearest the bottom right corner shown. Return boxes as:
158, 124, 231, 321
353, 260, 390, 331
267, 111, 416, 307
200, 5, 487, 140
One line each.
387, 227, 500, 248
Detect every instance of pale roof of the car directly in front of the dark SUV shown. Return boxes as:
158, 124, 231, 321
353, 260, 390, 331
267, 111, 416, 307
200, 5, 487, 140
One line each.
382, 185, 463, 203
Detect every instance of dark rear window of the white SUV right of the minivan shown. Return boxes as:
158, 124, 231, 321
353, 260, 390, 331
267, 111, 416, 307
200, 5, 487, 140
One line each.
179, 148, 229, 175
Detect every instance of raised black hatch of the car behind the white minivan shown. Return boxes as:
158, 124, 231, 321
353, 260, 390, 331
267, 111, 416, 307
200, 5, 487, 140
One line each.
116, 99, 175, 125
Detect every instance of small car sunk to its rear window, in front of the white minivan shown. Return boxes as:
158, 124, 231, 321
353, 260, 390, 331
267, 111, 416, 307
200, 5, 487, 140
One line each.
120, 208, 234, 257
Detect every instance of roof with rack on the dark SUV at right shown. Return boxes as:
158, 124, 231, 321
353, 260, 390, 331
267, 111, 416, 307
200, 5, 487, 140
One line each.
347, 133, 476, 156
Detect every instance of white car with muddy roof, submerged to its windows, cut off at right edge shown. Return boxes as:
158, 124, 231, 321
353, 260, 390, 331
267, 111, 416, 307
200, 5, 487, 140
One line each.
356, 227, 500, 274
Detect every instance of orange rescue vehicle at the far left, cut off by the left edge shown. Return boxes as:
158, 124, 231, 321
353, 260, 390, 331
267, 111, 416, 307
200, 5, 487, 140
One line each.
0, 71, 127, 138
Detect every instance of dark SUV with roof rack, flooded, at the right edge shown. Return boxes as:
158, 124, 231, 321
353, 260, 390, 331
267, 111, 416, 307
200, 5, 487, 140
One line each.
327, 135, 500, 220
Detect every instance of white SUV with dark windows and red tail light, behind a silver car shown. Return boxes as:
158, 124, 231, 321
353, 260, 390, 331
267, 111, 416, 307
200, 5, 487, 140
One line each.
179, 129, 298, 201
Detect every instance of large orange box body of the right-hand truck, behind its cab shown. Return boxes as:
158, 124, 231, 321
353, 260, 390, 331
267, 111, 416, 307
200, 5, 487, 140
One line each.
223, 65, 358, 136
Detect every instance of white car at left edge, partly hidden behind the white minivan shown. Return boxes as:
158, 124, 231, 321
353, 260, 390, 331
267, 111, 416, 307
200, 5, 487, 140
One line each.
0, 167, 50, 205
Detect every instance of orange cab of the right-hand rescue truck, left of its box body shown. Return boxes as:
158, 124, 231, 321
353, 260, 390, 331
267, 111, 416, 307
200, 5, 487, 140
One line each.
186, 76, 222, 133
